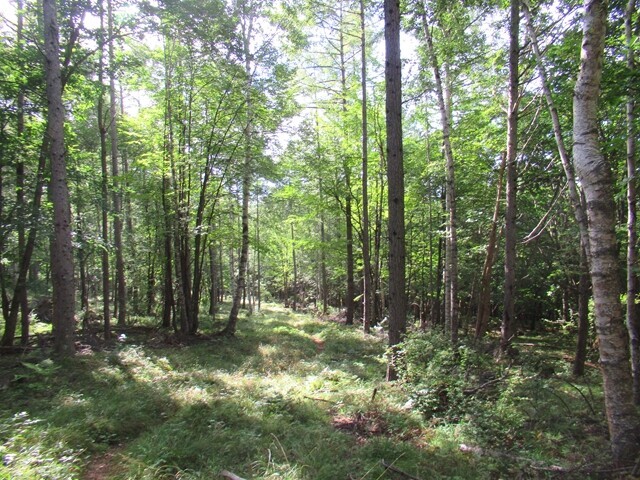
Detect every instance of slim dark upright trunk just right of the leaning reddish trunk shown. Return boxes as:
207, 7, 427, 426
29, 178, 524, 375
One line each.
500, 0, 520, 352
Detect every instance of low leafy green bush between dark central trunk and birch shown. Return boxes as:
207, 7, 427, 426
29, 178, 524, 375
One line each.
396, 332, 606, 469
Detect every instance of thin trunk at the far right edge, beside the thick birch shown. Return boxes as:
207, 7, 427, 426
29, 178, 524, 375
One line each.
624, 0, 640, 405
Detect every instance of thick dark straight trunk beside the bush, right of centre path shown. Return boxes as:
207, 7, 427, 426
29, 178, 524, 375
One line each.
384, 0, 407, 380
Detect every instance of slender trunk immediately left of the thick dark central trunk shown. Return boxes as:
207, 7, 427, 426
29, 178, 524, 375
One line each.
360, 0, 373, 333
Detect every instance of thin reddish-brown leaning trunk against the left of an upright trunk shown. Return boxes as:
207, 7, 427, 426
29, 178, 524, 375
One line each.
475, 155, 506, 340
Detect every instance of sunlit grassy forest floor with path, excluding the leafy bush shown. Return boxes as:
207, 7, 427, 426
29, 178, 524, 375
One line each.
0, 305, 624, 480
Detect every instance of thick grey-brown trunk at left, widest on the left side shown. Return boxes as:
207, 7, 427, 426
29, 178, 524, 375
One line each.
42, 0, 75, 356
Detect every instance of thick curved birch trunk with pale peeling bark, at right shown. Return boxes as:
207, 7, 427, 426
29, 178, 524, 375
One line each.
573, 0, 638, 464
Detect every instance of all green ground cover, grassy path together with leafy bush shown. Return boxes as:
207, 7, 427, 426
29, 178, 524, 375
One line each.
0, 305, 606, 480
